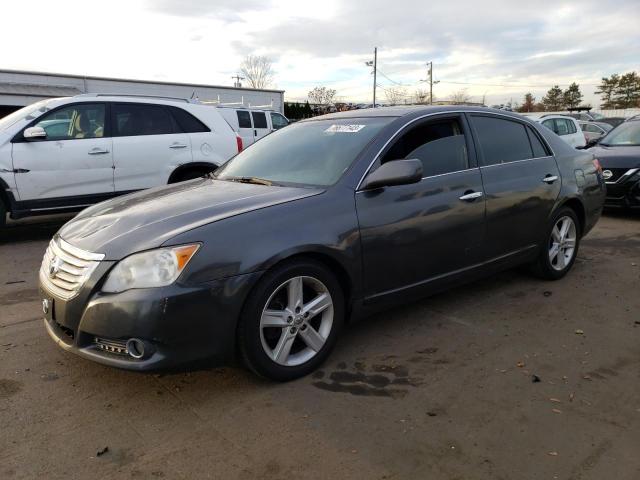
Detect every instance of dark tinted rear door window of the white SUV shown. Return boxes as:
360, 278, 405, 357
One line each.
112, 103, 174, 137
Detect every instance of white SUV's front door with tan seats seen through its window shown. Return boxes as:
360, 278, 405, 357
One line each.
11, 103, 114, 202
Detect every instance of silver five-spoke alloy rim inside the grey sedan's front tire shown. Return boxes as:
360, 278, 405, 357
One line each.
260, 276, 334, 366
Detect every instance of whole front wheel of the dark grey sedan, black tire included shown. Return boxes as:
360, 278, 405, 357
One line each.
238, 259, 345, 382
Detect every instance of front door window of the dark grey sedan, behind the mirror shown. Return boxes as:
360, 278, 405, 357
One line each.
381, 118, 469, 177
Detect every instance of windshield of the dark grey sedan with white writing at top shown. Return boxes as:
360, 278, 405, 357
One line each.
216, 117, 393, 186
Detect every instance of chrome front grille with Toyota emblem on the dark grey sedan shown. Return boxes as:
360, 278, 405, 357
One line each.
40, 236, 104, 300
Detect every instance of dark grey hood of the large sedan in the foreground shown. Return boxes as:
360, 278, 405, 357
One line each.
58, 178, 323, 260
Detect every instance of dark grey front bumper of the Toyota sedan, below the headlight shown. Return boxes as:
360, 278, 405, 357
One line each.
40, 268, 260, 370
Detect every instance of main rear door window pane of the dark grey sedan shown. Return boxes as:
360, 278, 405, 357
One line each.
472, 115, 534, 166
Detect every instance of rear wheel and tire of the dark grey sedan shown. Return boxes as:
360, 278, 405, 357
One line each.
532, 207, 581, 280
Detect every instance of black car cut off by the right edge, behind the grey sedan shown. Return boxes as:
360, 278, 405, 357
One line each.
588, 118, 640, 208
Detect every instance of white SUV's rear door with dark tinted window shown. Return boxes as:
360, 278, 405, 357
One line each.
111, 103, 192, 192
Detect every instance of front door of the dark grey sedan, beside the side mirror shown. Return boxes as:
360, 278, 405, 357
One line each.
356, 114, 485, 299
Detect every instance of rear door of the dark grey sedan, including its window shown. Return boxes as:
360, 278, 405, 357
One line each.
469, 114, 562, 260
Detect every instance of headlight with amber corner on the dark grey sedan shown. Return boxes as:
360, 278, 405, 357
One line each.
102, 243, 200, 293
